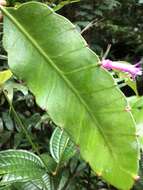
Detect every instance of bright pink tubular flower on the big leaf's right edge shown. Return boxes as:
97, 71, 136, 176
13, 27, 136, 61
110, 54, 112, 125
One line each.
102, 59, 142, 79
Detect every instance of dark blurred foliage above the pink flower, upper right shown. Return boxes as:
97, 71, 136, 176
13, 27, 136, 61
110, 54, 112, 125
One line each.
63, 0, 143, 62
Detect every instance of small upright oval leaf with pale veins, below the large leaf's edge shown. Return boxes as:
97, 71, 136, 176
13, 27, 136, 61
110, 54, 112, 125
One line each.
50, 127, 76, 163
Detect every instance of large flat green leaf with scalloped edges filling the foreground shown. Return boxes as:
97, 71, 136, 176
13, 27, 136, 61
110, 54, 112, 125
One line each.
2, 2, 138, 190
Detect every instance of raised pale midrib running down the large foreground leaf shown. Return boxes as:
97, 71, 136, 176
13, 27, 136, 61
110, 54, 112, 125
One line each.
0, 5, 132, 173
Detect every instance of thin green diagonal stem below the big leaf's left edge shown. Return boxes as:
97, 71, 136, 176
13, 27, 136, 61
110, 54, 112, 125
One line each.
3, 90, 47, 172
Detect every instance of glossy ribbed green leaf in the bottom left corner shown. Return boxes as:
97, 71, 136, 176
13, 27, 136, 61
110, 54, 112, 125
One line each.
0, 150, 45, 185
